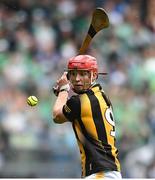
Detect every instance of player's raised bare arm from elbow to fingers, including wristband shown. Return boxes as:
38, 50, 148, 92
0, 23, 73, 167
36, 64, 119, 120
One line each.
53, 73, 69, 124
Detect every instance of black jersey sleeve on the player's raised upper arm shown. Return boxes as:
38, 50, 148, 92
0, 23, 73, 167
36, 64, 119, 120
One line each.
63, 96, 80, 122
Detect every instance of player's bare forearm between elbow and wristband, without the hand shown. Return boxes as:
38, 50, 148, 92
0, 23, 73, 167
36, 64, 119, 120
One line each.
53, 91, 68, 123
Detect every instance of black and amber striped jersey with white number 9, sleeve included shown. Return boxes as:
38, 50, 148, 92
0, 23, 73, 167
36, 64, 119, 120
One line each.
63, 84, 120, 177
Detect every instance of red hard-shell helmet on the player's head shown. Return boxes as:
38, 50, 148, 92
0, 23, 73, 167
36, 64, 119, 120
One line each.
68, 55, 98, 73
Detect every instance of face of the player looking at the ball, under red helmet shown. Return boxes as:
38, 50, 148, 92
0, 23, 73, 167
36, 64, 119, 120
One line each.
69, 70, 94, 93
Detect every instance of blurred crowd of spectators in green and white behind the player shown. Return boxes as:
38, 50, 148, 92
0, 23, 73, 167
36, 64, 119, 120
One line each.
0, 0, 155, 178
